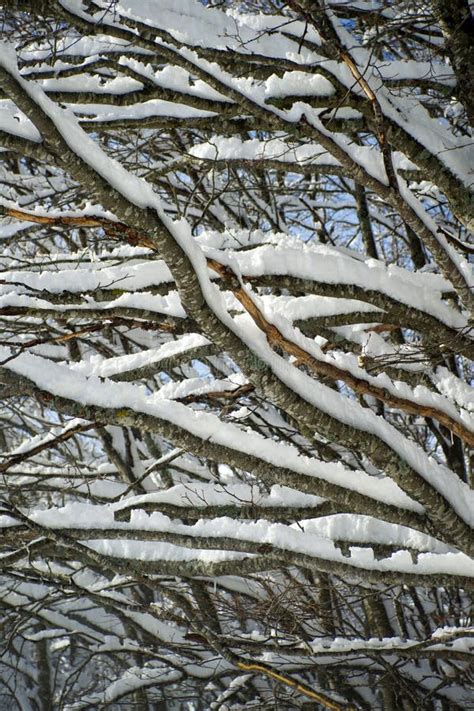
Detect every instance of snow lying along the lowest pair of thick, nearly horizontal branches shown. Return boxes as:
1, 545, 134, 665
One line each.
28, 504, 474, 578
